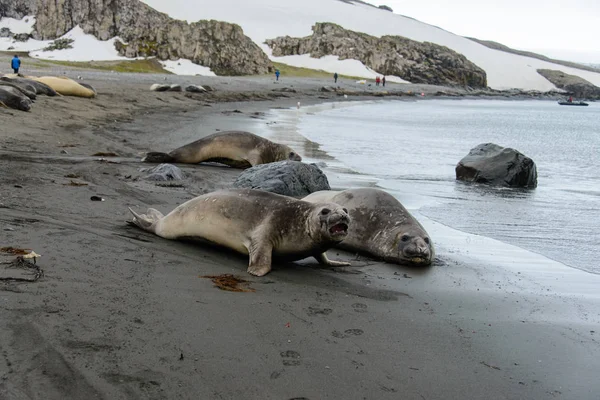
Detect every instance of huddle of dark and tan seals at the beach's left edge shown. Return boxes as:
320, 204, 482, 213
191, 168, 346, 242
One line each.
0, 74, 96, 111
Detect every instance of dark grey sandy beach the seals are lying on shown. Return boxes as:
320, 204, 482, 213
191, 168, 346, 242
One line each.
0, 61, 600, 399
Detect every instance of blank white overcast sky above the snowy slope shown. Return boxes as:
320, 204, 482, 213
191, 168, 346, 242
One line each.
367, 0, 600, 64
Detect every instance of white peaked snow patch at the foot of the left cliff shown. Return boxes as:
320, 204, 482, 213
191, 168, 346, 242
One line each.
29, 25, 131, 61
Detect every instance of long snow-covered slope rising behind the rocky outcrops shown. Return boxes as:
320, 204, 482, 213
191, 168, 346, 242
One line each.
0, 0, 600, 91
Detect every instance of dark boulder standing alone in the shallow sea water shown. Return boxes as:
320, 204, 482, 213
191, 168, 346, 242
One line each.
456, 143, 537, 188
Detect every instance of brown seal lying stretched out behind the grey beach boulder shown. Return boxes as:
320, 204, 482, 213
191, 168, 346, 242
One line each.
142, 131, 302, 169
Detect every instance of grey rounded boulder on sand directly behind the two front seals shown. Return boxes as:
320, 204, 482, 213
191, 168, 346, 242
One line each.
233, 161, 331, 197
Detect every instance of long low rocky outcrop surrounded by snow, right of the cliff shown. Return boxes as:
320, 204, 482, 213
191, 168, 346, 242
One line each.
266, 23, 487, 88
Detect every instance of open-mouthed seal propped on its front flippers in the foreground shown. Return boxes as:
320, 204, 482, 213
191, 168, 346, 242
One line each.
129, 189, 350, 276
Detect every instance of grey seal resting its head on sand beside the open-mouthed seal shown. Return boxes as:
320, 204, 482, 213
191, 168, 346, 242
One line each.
302, 188, 435, 266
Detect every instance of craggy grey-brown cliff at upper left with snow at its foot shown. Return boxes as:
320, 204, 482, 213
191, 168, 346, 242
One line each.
0, 0, 272, 75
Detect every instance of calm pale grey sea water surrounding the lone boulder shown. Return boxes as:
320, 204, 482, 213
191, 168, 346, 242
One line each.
266, 99, 600, 273
